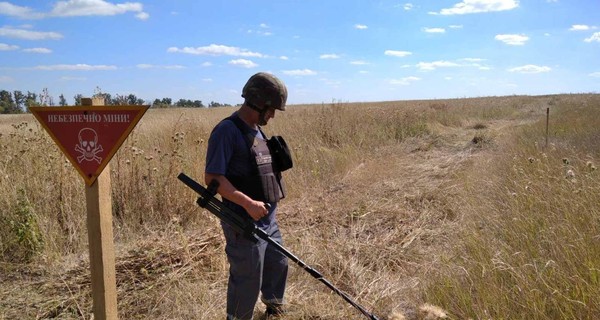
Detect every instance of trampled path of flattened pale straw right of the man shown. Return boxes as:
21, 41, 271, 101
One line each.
284, 120, 529, 319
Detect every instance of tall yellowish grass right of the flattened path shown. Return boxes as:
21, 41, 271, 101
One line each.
425, 96, 600, 319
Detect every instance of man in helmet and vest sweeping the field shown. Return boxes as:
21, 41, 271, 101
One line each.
205, 72, 288, 320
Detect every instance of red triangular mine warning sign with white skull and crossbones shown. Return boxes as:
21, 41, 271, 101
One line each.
29, 106, 149, 186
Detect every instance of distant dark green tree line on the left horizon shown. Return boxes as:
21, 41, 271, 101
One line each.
0, 88, 231, 114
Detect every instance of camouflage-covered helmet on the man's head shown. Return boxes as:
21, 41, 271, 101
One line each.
242, 72, 287, 111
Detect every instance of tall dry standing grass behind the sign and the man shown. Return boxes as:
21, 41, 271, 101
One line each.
0, 104, 428, 260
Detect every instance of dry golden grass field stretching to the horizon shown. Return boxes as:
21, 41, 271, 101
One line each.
0, 94, 600, 320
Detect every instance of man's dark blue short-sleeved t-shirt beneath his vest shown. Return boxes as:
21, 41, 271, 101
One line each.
204, 113, 277, 228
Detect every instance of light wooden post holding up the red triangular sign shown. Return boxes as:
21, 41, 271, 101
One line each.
81, 98, 118, 320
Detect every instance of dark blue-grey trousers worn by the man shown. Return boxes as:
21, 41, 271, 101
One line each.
222, 222, 288, 320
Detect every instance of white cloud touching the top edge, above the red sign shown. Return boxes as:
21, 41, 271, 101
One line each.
49, 0, 149, 20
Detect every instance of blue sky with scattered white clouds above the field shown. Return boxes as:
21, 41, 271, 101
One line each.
0, 0, 600, 105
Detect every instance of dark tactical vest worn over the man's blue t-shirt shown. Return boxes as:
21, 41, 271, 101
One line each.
223, 115, 285, 203
